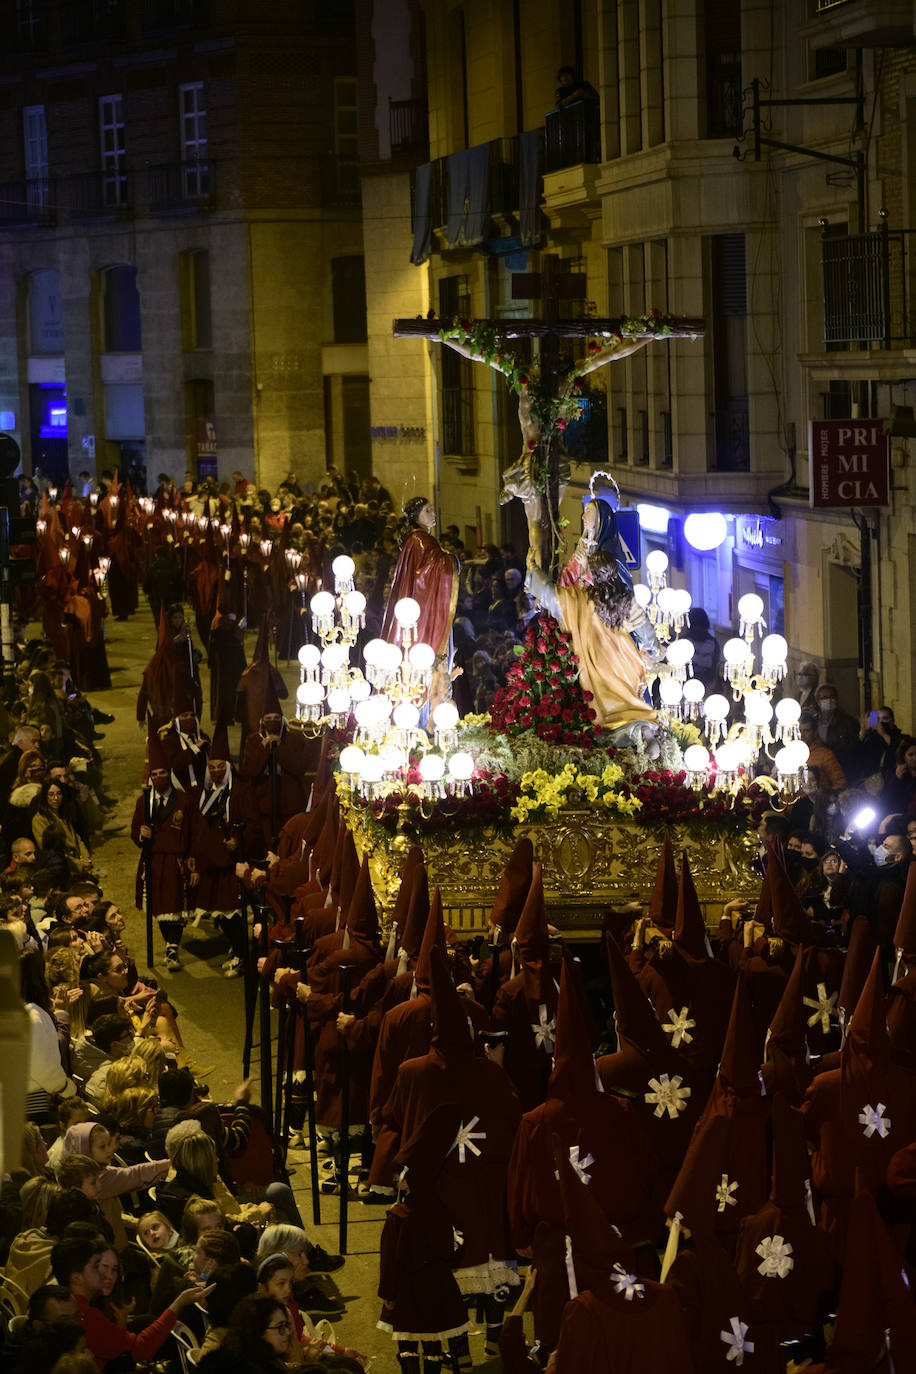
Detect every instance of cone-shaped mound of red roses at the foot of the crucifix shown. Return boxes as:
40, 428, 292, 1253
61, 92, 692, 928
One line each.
490, 616, 600, 749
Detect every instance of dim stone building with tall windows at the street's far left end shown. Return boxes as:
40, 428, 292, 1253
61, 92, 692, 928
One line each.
0, 0, 369, 486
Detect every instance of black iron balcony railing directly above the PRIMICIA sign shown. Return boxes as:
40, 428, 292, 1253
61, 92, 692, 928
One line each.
821, 224, 912, 348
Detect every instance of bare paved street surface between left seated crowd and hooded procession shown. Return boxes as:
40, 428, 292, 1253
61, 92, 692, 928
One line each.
77, 605, 501, 1374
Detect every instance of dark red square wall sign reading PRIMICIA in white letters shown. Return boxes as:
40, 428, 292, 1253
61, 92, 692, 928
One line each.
810, 419, 890, 510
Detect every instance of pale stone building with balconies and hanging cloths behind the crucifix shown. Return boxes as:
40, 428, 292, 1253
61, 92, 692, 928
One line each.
361, 0, 916, 727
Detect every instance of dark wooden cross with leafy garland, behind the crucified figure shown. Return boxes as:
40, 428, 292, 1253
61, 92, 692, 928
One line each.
393, 276, 706, 574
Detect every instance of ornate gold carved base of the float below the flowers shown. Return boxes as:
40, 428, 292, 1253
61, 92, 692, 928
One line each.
342, 802, 759, 940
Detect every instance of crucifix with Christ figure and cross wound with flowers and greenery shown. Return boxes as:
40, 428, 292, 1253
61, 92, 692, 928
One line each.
394, 254, 705, 573
